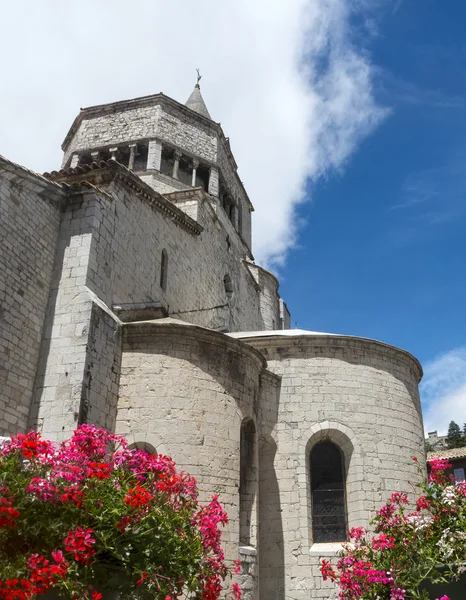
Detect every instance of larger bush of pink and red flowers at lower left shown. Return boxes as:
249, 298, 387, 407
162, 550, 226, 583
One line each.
0, 425, 240, 600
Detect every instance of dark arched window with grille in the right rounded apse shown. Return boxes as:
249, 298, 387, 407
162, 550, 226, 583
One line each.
310, 441, 348, 543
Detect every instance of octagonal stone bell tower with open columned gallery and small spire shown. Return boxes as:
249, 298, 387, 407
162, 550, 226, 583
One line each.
62, 80, 254, 256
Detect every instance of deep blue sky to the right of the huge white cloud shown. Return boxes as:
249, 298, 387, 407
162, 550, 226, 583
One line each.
282, 0, 466, 431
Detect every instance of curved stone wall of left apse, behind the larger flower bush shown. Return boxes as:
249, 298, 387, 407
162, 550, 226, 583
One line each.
117, 319, 265, 575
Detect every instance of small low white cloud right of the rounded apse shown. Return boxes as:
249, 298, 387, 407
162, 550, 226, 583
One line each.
420, 347, 466, 434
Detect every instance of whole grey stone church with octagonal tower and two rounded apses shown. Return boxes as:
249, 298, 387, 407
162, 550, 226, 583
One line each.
0, 84, 424, 600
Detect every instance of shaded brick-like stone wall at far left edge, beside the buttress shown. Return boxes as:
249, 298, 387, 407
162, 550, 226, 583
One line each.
0, 159, 65, 435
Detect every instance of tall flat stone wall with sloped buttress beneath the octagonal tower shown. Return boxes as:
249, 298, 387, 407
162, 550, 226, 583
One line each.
30, 168, 280, 439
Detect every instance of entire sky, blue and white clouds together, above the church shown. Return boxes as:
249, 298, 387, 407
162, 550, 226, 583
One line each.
0, 0, 466, 432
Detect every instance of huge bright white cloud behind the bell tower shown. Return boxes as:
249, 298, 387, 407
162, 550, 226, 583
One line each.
0, 0, 386, 265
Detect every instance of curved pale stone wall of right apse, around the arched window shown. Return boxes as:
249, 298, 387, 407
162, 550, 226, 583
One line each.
238, 334, 424, 600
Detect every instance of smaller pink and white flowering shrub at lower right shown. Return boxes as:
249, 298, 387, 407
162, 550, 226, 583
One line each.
321, 459, 466, 600
